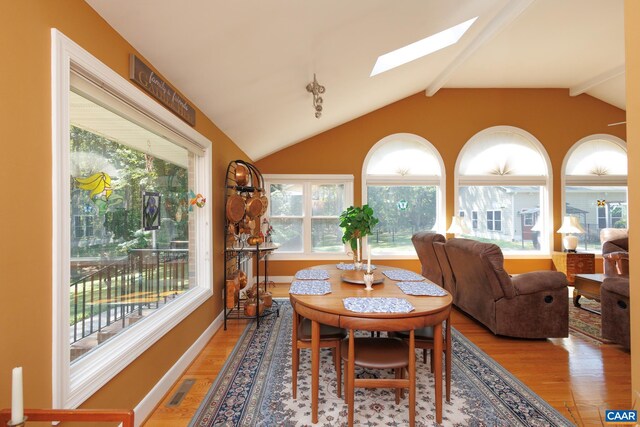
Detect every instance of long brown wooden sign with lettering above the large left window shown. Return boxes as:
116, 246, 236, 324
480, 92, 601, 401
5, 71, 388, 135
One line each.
129, 54, 196, 126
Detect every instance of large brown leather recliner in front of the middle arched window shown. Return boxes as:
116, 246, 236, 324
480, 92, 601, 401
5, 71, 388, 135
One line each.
436, 238, 569, 338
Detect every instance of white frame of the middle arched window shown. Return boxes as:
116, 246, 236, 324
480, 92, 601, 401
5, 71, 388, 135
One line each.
453, 126, 553, 259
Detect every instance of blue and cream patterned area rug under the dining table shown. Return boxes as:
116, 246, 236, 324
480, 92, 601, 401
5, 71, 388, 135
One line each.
189, 303, 573, 427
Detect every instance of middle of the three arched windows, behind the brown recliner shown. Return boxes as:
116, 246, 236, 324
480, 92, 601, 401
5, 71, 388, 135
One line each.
456, 126, 551, 253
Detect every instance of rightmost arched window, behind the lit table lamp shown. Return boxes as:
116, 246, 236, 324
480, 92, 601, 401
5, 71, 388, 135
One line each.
563, 134, 628, 252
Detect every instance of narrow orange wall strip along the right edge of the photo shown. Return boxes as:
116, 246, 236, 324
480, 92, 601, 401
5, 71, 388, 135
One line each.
624, 0, 640, 410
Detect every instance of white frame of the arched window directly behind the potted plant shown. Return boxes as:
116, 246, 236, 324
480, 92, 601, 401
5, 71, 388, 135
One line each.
362, 133, 447, 259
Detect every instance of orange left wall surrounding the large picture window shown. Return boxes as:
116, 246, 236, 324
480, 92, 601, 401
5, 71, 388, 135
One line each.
0, 0, 247, 414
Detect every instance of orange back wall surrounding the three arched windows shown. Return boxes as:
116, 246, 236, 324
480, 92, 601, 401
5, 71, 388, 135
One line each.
256, 89, 626, 275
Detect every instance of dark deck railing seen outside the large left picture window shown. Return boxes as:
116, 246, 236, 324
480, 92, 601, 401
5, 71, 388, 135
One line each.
70, 249, 189, 344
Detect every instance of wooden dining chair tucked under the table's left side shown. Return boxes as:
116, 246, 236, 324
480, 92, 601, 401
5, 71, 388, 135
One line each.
291, 311, 347, 399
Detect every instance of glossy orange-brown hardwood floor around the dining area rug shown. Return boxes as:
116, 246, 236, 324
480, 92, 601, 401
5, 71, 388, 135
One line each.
144, 284, 631, 427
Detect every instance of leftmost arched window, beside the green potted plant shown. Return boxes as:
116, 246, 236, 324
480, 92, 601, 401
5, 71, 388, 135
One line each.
362, 133, 445, 256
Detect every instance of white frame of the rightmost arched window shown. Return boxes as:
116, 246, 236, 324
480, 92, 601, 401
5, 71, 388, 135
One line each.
560, 133, 630, 253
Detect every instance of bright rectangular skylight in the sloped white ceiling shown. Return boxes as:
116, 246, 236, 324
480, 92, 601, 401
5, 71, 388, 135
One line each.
369, 16, 478, 77
